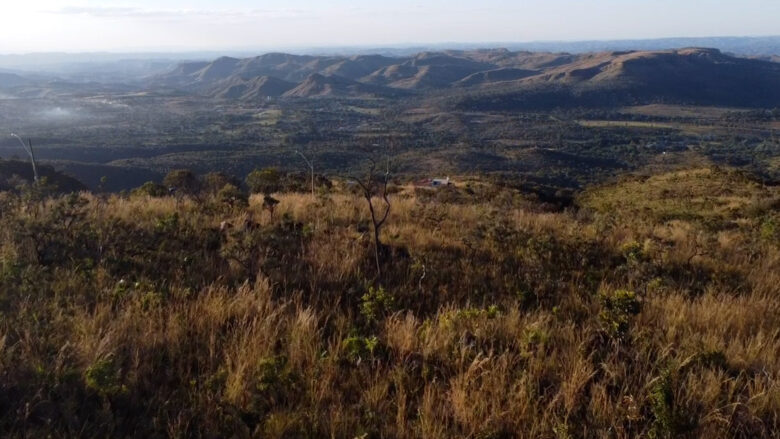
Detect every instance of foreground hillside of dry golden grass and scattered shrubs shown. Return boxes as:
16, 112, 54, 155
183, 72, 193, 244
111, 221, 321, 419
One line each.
0, 168, 780, 438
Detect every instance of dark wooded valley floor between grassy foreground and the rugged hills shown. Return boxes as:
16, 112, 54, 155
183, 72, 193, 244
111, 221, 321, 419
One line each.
0, 86, 780, 192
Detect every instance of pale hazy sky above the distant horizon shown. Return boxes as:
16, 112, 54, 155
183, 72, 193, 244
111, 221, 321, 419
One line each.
0, 0, 780, 53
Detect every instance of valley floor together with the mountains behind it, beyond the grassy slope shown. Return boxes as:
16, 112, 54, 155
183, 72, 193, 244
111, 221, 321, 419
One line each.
0, 49, 780, 191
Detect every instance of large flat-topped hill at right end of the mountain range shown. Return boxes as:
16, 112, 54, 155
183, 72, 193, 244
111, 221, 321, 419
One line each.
460, 49, 780, 109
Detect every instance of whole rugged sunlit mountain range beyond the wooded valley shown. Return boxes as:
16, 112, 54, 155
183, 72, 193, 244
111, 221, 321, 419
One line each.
149, 48, 780, 109
